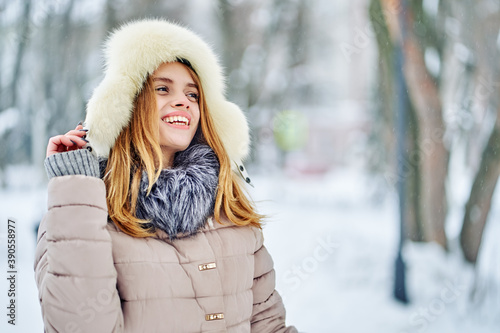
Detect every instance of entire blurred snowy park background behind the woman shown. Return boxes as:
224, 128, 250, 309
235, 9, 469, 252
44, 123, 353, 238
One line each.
0, 0, 500, 332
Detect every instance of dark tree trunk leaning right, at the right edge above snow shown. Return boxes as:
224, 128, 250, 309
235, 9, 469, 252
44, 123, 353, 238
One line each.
460, 119, 500, 263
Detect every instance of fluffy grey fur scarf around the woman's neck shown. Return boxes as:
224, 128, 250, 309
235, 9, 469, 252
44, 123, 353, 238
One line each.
136, 144, 219, 239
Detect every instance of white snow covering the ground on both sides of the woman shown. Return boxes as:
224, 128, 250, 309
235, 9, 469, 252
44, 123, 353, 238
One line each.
0, 165, 500, 333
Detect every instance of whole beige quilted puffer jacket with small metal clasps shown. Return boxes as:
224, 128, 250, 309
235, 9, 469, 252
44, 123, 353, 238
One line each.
35, 175, 296, 333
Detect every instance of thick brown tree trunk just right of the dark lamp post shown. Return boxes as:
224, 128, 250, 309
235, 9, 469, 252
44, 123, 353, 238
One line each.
396, 1, 449, 248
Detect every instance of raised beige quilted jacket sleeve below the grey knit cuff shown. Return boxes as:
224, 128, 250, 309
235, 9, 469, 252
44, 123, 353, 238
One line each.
35, 175, 123, 332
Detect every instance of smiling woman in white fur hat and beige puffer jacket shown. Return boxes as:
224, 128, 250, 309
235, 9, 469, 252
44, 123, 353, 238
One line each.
35, 20, 296, 332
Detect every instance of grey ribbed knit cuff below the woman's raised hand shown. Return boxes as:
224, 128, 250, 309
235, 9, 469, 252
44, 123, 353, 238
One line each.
45, 149, 100, 179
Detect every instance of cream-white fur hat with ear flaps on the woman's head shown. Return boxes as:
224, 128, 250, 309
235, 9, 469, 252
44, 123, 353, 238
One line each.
85, 19, 250, 164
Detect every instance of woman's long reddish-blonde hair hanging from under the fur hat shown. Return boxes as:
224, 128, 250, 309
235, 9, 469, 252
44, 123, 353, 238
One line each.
104, 64, 263, 237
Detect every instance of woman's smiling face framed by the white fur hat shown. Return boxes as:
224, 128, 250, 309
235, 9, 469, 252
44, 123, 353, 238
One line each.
153, 62, 200, 165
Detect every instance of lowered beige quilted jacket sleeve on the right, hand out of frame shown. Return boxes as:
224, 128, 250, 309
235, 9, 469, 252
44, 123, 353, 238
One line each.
251, 230, 297, 333
